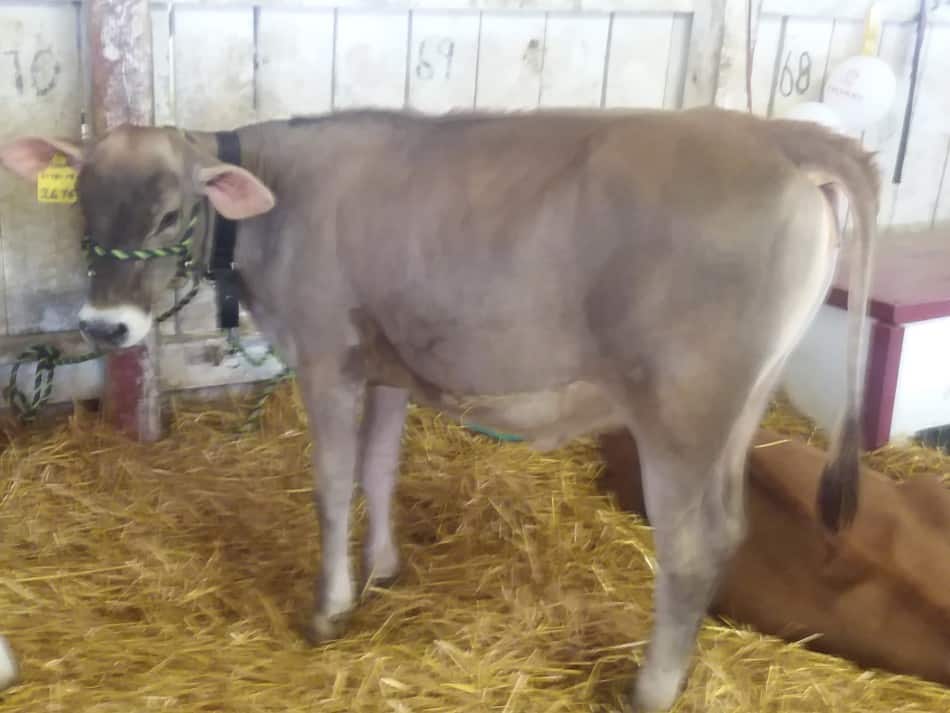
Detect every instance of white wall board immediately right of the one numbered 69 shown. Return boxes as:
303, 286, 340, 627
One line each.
475, 13, 545, 110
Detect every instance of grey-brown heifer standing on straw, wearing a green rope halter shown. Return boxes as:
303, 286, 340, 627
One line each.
0, 108, 878, 710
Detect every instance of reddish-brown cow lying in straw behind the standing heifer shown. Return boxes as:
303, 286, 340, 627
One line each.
600, 430, 950, 685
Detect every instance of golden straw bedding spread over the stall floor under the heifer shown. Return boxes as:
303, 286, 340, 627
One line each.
0, 384, 950, 713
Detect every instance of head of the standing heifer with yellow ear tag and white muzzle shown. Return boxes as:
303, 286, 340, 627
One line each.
0, 125, 274, 349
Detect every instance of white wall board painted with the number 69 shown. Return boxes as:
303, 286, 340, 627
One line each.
409, 11, 481, 114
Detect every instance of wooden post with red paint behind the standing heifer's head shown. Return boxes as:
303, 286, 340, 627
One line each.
84, 0, 161, 441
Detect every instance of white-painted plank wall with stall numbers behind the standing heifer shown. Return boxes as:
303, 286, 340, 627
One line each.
0, 0, 950, 412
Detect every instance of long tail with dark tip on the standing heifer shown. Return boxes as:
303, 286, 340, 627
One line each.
765, 120, 880, 533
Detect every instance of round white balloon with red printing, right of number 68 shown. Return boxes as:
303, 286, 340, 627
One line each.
824, 55, 897, 130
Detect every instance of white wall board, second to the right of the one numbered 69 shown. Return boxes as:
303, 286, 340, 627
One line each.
538, 14, 608, 107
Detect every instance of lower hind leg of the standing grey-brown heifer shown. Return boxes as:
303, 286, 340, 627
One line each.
633, 368, 779, 712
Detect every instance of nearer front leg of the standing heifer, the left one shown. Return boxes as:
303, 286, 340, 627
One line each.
300, 374, 364, 643
